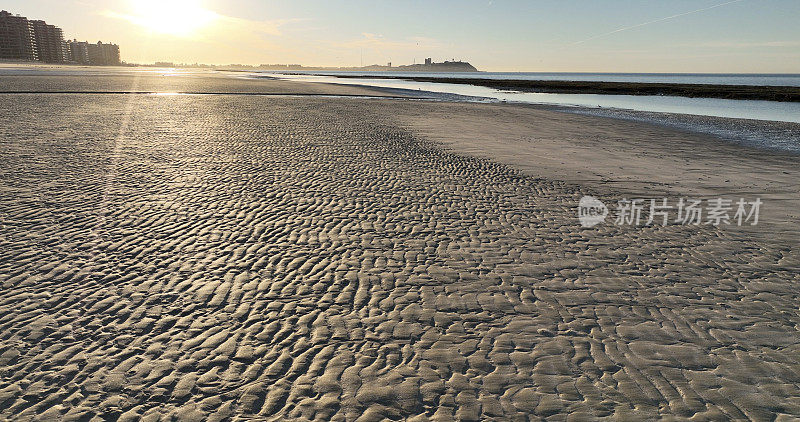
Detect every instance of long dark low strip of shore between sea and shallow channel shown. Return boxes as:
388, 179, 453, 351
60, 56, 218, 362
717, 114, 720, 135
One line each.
316, 72, 800, 102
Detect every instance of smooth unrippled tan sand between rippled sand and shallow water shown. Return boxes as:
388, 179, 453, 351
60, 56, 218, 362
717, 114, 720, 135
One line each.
391, 103, 800, 244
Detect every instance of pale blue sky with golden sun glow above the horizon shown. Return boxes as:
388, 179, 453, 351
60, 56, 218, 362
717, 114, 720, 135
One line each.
0, 0, 800, 73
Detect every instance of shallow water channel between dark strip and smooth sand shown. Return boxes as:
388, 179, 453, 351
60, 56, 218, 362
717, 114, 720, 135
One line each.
260, 74, 800, 154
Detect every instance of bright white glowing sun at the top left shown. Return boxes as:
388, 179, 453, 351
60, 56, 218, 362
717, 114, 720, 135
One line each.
129, 0, 219, 37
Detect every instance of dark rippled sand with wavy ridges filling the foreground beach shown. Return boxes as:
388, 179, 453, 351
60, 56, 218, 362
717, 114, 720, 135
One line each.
0, 95, 800, 421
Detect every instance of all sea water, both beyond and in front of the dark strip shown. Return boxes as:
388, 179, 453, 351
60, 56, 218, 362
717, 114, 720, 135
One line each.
262, 71, 800, 155
